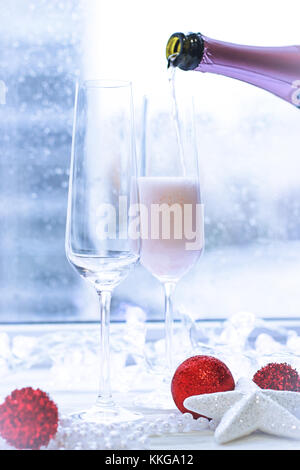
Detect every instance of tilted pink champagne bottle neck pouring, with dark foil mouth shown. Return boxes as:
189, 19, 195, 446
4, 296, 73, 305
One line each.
166, 33, 300, 108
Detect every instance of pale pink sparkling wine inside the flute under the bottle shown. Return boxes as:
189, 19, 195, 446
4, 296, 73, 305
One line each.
139, 176, 204, 281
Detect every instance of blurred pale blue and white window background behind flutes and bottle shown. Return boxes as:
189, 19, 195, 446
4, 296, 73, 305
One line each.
0, 0, 300, 322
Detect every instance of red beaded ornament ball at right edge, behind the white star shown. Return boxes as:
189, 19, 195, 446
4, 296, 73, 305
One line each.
252, 362, 300, 392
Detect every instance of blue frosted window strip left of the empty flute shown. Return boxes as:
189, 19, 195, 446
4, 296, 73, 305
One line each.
0, 0, 81, 321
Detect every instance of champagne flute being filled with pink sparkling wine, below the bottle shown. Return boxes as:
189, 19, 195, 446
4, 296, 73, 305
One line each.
138, 81, 204, 407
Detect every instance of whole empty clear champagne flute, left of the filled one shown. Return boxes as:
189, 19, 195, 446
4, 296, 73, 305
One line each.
66, 80, 140, 423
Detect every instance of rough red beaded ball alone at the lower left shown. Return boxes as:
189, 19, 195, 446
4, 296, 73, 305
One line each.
0, 387, 58, 450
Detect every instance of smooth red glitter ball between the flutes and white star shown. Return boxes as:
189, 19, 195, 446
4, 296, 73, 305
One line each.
171, 356, 235, 418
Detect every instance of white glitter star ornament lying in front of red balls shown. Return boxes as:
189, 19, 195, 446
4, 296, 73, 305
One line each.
184, 378, 300, 444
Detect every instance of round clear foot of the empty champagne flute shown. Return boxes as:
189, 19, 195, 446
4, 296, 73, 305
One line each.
71, 403, 143, 424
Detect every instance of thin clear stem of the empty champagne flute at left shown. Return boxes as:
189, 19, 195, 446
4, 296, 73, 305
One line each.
97, 291, 112, 405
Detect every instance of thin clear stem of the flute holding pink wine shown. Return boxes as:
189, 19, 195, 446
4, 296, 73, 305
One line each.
164, 282, 176, 372
